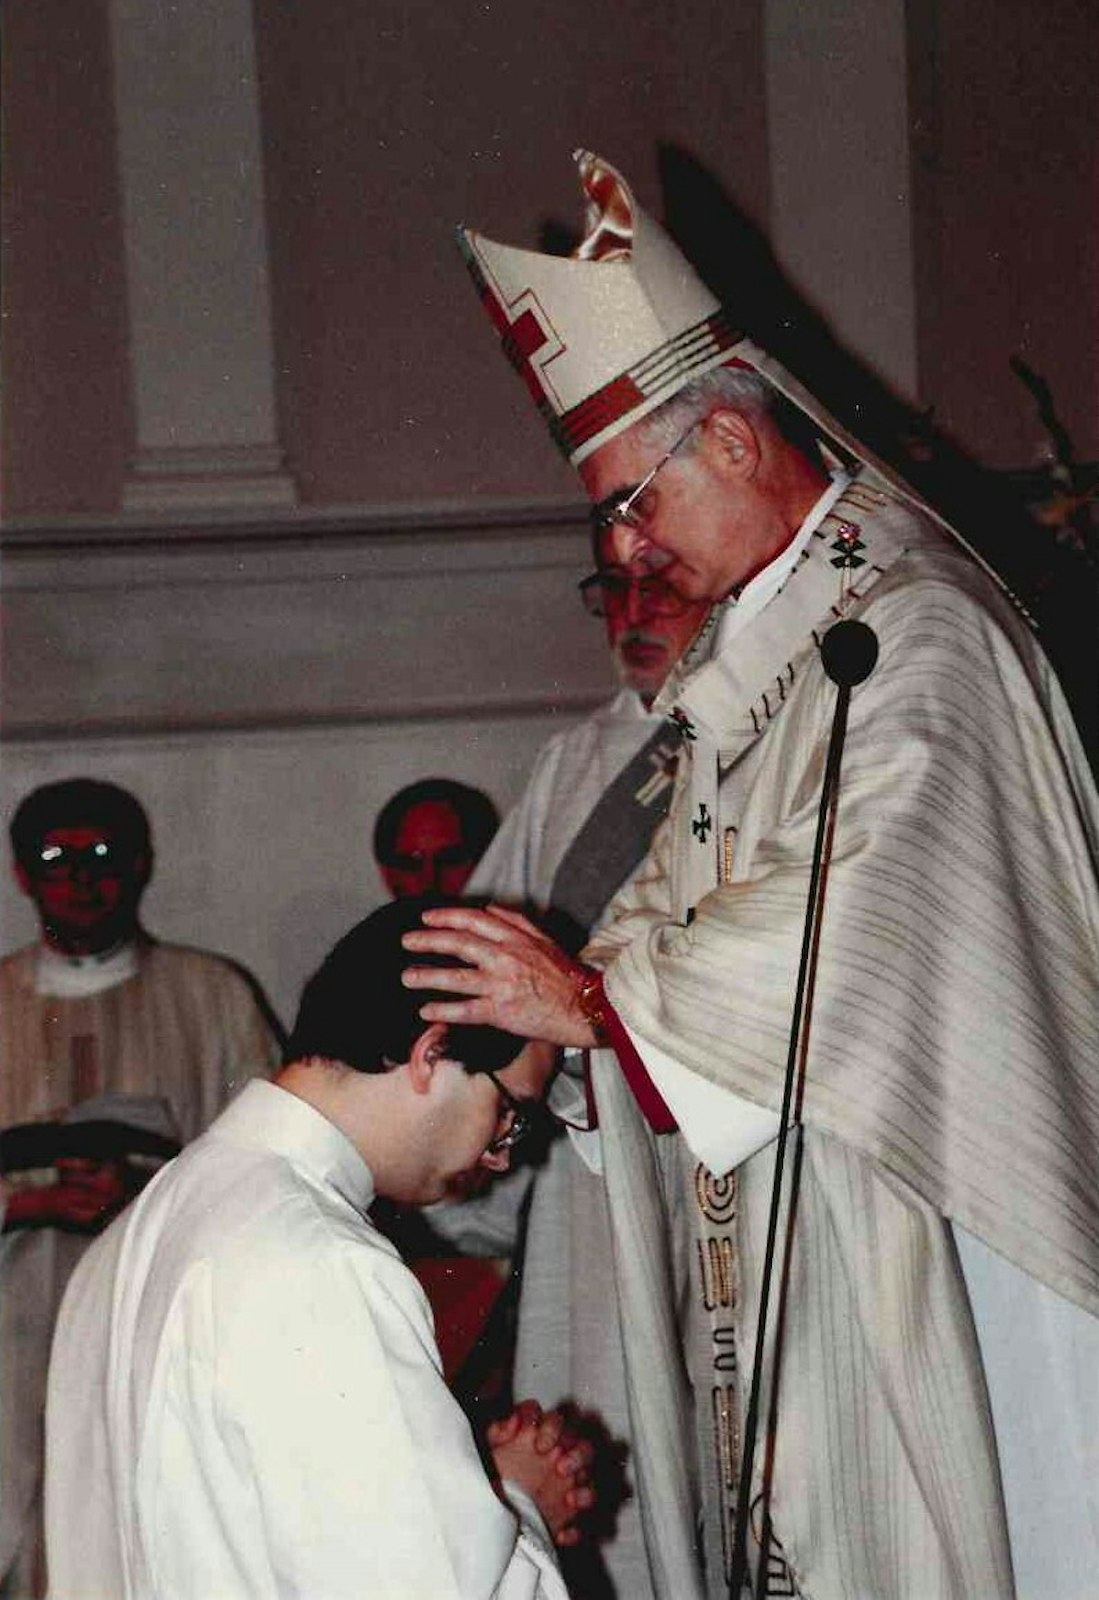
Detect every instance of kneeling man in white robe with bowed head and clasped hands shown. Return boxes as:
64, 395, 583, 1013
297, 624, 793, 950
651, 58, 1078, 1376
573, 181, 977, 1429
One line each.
46, 901, 592, 1600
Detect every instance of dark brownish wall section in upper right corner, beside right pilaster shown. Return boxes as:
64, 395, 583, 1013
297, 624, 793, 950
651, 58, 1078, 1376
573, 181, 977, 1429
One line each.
905, 0, 1099, 466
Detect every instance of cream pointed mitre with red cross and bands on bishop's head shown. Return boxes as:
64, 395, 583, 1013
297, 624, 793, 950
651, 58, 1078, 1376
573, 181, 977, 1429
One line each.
458, 150, 741, 466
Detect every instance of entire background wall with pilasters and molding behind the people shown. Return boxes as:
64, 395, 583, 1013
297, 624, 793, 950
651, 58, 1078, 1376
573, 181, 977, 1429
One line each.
0, 0, 1099, 1011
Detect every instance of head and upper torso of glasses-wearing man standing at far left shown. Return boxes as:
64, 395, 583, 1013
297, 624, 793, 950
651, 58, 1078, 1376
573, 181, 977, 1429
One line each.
0, 778, 278, 1142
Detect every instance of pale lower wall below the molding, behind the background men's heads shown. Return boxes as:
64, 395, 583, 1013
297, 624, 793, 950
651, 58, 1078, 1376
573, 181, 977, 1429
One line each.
0, 714, 585, 1024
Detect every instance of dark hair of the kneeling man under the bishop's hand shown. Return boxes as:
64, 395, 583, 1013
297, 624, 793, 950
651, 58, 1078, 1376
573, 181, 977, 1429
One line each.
285, 894, 526, 1072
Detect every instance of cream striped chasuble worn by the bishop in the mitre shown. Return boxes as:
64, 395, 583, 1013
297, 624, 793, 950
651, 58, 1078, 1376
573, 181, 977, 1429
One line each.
589, 483, 1099, 1600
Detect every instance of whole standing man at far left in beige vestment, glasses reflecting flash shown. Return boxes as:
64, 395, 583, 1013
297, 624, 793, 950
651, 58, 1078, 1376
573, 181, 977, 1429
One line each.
0, 778, 278, 1600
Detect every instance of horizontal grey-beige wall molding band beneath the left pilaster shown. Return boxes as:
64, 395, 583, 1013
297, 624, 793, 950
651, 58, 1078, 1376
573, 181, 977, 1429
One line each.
3, 506, 609, 746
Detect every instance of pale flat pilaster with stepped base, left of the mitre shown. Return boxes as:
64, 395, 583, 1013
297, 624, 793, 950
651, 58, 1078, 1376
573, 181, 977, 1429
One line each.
110, 0, 294, 512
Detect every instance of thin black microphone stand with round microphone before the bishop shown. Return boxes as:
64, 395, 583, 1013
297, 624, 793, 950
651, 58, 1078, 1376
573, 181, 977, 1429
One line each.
728, 621, 878, 1600
